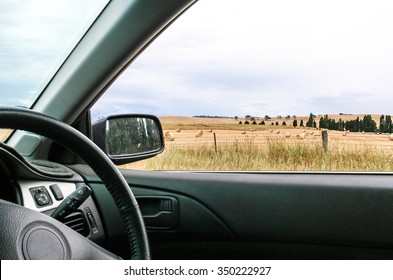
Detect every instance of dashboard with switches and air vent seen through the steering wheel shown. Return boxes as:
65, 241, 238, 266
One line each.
0, 145, 105, 244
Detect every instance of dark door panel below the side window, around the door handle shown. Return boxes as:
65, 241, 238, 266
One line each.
76, 165, 393, 259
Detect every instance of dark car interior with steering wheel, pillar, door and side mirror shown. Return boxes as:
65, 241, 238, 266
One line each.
0, 0, 393, 260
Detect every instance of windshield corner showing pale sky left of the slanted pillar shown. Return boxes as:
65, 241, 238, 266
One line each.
0, 0, 108, 107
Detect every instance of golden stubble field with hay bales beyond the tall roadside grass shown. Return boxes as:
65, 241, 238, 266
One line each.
160, 115, 393, 150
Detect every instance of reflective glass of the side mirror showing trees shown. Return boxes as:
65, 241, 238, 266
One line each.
105, 116, 162, 156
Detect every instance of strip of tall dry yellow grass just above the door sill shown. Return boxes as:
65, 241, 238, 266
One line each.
123, 137, 393, 171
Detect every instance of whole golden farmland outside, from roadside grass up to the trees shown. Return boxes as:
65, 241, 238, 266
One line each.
122, 115, 393, 171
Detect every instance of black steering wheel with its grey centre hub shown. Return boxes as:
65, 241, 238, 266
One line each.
0, 107, 150, 260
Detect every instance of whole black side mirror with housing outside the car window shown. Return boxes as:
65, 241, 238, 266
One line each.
93, 114, 164, 165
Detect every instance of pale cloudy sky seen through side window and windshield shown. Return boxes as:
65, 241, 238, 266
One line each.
0, 0, 393, 118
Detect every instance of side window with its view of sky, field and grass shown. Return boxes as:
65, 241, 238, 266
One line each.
92, 0, 393, 171
